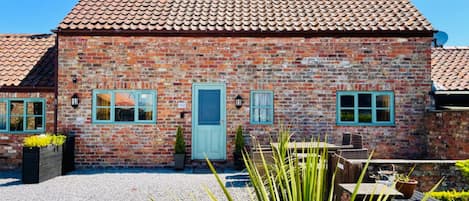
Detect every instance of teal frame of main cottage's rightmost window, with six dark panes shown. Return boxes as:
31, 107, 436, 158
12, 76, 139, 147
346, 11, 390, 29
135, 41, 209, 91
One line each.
336, 91, 395, 126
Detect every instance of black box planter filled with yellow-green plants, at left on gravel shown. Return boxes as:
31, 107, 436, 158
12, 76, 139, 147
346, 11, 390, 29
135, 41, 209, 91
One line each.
22, 134, 66, 184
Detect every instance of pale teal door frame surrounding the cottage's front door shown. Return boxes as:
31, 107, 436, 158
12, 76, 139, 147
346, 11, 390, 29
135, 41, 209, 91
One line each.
191, 82, 227, 160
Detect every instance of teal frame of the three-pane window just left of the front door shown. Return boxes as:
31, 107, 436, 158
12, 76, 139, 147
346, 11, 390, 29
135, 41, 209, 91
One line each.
92, 89, 158, 124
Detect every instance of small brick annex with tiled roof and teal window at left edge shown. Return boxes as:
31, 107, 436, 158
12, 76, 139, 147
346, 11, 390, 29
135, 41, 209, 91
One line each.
0, 34, 57, 169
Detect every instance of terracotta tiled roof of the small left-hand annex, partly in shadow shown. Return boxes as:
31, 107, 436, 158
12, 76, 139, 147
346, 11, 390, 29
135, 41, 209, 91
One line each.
0, 34, 57, 87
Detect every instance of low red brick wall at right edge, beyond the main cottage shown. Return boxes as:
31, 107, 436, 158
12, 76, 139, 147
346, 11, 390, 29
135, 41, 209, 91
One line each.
425, 111, 469, 159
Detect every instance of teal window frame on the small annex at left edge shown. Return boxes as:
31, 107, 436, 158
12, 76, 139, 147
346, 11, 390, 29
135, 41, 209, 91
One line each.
0, 98, 47, 134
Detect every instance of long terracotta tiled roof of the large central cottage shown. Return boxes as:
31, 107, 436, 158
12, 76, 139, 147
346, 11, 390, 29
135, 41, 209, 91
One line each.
58, 0, 433, 32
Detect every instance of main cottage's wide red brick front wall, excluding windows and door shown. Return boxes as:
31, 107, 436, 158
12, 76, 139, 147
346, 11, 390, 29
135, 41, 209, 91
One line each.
58, 36, 431, 167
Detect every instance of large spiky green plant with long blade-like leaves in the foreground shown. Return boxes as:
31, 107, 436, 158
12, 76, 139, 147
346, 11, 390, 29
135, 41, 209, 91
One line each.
206, 127, 441, 201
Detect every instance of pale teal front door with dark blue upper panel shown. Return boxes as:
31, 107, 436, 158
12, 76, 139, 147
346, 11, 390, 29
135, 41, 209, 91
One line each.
192, 83, 226, 160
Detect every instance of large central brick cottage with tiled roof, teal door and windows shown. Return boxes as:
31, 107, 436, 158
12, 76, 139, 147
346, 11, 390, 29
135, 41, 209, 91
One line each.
1, 0, 433, 167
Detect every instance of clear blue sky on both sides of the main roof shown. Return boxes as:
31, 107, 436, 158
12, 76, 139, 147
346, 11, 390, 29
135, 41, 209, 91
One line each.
0, 0, 469, 46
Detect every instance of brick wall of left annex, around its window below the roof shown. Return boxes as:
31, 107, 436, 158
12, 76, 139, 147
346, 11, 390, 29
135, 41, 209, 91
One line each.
0, 92, 55, 169
